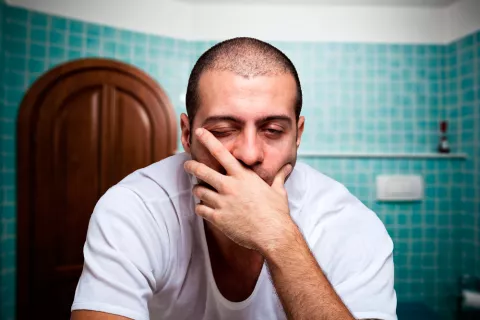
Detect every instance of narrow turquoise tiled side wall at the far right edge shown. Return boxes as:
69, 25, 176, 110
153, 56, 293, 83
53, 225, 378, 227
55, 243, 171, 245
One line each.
446, 32, 480, 276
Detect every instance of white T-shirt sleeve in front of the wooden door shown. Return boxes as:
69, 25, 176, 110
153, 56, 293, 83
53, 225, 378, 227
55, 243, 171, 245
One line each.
72, 186, 169, 319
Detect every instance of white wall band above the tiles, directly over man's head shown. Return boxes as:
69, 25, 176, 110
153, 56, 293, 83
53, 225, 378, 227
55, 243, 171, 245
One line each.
191, 4, 445, 43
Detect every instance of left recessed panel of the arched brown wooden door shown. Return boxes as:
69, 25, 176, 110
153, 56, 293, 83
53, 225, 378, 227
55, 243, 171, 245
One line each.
54, 87, 102, 268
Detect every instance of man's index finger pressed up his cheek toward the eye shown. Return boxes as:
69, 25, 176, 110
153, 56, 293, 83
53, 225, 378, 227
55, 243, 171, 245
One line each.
195, 128, 244, 175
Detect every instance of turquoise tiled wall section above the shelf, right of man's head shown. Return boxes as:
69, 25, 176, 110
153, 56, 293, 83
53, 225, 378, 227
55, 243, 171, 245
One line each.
266, 43, 443, 152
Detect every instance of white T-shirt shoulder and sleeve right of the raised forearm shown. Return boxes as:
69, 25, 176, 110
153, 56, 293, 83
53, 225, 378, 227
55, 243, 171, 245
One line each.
299, 166, 396, 319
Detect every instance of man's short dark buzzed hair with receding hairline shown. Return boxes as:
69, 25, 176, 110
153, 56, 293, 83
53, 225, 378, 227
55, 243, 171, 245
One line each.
186, 37, 302, 127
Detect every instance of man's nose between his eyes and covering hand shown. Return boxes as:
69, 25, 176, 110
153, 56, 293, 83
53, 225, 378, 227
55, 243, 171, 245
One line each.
231, 132, 264, 167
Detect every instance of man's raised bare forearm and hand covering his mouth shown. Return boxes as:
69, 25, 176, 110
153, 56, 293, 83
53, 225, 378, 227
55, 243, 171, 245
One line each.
185, 129, 353, 320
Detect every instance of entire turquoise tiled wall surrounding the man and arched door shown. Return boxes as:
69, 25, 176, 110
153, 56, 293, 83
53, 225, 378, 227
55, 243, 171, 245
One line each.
0, 6, 480, 319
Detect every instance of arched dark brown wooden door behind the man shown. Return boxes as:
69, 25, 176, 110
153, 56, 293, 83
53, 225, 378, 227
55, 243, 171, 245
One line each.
17, 59, 177, 319
